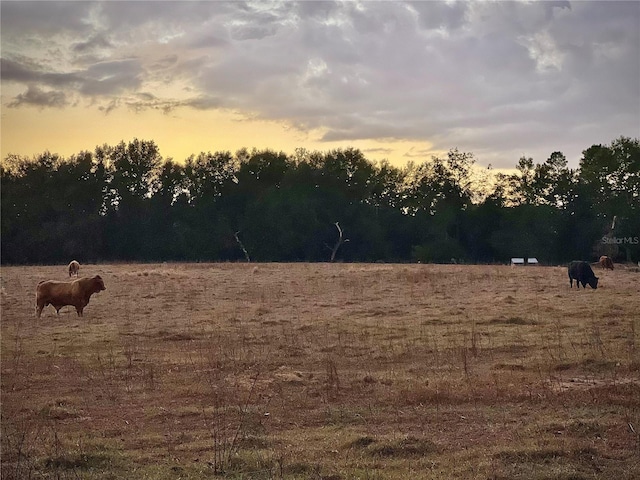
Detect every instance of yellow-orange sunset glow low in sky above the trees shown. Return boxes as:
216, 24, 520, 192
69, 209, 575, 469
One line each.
0, 106, 446, 166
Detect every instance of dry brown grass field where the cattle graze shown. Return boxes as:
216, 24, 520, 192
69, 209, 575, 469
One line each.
1, 263, 640, 480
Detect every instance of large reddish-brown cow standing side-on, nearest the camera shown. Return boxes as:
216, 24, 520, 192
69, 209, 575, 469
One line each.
36, 275, 106, 318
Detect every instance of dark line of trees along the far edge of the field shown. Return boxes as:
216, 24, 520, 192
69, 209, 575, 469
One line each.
0, 137, 640, 264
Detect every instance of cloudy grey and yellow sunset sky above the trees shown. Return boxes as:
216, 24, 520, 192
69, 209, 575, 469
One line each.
0, 0, 640, 169
